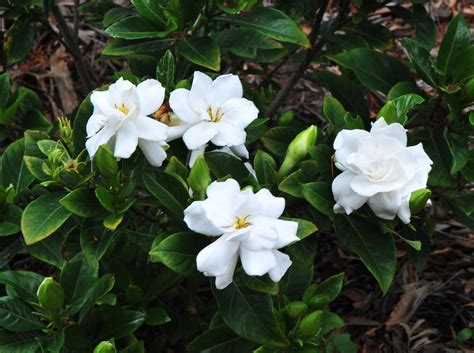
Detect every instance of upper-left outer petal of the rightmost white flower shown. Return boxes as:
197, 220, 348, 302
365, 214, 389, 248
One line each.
334, 129, 370, 170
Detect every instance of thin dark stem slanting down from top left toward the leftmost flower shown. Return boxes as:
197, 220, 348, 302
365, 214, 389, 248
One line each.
51, 0, 94, 92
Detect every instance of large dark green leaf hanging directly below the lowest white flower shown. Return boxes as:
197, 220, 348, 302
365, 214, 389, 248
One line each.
213, 278, 289, 348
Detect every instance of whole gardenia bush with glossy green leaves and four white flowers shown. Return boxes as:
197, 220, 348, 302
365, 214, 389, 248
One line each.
0, 0, 474, 353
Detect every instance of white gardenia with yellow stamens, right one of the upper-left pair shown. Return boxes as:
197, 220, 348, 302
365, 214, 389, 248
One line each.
170, 71, 258, 166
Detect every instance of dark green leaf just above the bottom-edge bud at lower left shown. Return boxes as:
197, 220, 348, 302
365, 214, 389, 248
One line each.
97, 305, 145, 340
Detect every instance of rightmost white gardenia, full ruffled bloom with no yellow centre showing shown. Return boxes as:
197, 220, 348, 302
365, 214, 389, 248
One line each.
332, 118, 433, 223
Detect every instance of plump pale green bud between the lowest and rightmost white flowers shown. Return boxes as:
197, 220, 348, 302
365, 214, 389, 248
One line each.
278, 125, 318, 180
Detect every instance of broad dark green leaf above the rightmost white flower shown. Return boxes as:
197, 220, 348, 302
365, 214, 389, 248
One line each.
329, 48, 413, 93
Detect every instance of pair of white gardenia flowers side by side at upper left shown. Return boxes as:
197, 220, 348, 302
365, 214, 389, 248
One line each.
86, 72, 258, 167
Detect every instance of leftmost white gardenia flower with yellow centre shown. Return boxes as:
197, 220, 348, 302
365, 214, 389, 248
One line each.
86, 78, 168, 167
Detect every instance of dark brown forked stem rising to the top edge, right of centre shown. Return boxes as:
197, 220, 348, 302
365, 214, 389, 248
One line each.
265, 0, 349, 116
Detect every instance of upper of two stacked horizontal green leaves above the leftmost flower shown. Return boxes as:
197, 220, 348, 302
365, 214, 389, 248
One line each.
105, 16, 169, 39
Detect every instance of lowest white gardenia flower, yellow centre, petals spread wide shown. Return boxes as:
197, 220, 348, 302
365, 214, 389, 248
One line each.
184, 179, 299, 289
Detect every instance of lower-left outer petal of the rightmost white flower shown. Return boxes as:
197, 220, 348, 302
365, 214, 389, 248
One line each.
332, 171, 367, 214
